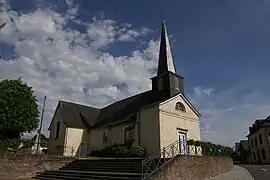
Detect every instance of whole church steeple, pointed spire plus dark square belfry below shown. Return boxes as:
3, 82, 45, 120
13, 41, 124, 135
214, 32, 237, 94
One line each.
152, 21, 184, 99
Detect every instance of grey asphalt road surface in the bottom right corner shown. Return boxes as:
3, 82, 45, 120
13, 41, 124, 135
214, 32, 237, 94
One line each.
237, 164, 270, 180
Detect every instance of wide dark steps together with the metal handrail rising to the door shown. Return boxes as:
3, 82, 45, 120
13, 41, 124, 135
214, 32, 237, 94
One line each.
34, 141, 181, 180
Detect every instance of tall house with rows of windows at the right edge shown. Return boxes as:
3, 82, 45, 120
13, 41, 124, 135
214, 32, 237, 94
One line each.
247, 116, 270, 163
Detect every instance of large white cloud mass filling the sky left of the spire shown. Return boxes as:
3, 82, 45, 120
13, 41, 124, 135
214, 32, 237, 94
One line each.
0, 0, 158, 137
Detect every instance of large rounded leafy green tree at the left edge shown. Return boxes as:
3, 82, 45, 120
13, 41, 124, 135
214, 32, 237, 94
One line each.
0, 78, 39, 140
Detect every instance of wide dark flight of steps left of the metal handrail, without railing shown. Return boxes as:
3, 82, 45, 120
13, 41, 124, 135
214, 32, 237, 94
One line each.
34, 159, 149, 180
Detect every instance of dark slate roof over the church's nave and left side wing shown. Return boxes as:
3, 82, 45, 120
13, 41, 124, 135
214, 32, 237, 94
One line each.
49, 90, 159, 129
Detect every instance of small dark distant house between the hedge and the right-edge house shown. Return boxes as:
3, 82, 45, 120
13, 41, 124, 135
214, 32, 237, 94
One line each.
235, 140, 251, 162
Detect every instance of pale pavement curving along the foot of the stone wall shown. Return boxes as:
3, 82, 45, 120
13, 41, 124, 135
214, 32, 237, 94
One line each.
207, 166, 254, 180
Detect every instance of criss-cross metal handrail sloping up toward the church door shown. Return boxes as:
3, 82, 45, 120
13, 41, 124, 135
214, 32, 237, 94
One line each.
141, 140, 181, 180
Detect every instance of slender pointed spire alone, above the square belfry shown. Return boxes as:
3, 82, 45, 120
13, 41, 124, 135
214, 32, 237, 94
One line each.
157, 21, 175, 76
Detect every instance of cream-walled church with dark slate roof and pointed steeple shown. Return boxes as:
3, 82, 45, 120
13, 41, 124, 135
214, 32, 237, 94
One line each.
48, 21, 201, 156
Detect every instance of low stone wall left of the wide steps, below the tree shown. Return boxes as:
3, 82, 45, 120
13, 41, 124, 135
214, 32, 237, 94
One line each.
0, 155, 74, 180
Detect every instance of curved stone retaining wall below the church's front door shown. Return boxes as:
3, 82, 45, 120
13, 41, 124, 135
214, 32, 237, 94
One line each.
151, 156, 233, 180
